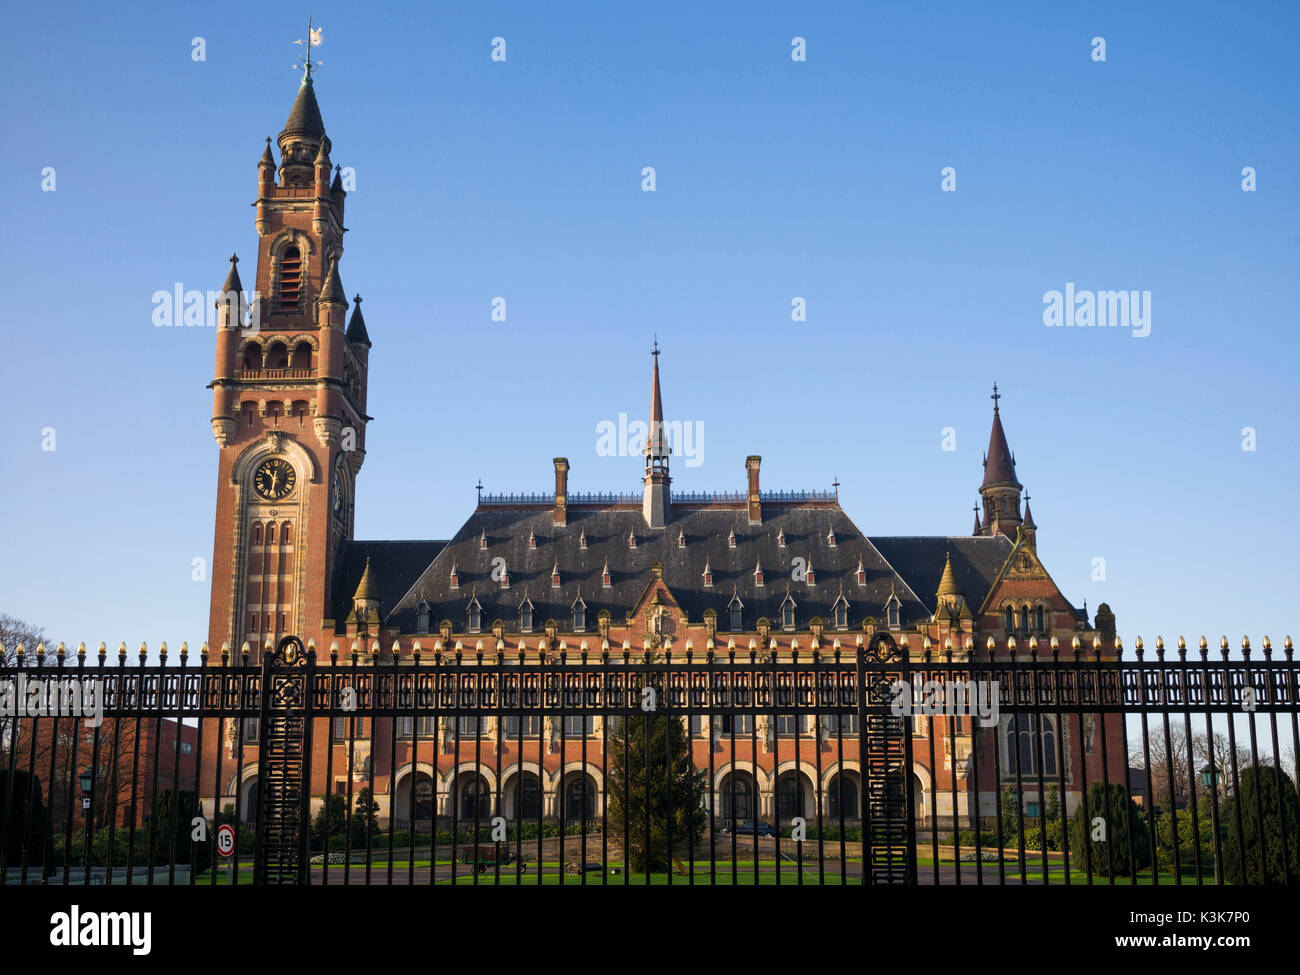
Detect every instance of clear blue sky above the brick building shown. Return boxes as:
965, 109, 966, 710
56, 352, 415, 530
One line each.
0, 1, 1300, 657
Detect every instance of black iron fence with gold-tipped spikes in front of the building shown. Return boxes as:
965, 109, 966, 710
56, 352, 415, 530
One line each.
0, 634, 1300, 885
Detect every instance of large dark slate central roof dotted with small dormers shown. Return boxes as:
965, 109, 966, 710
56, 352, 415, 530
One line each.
377, 503, 943, 633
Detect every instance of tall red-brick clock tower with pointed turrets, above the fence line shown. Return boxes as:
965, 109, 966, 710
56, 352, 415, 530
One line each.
208, 68, 371, 660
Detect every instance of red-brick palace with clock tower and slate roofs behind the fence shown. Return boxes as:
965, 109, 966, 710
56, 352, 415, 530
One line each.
204, 65, 1125, 827
